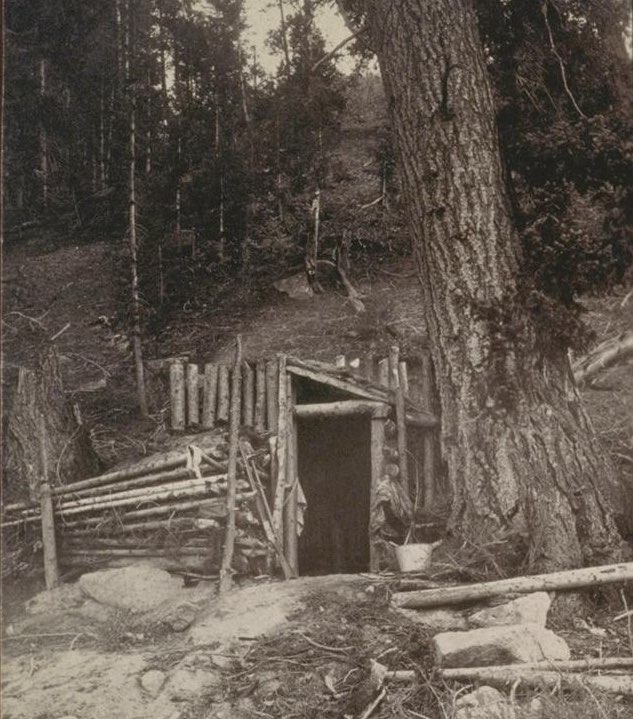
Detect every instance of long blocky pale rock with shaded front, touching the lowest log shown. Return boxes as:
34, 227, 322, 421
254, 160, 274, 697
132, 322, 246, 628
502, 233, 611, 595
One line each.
433, 624, 570, 667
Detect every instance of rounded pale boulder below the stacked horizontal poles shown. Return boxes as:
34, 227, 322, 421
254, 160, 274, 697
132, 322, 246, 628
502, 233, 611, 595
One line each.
79, 565, 183, 612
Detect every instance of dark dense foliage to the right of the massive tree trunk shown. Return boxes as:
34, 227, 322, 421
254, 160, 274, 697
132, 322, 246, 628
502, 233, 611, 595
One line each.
476, 0, 633, 306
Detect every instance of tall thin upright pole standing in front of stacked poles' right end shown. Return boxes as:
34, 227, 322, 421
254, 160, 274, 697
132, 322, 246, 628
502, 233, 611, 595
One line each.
218, 335, 242, 594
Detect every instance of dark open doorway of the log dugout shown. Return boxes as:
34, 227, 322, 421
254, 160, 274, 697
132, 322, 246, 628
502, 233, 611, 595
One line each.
297, 416, 371, 575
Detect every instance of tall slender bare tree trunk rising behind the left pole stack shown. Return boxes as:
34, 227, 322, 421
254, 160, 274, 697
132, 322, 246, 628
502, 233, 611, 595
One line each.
125, 0, 149, 417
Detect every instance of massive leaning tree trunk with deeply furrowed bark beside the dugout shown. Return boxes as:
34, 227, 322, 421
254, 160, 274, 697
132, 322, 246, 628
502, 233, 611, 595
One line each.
366, 0, 620, 571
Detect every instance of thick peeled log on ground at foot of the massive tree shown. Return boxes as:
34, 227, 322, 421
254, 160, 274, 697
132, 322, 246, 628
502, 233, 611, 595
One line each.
392, 562, 633, 609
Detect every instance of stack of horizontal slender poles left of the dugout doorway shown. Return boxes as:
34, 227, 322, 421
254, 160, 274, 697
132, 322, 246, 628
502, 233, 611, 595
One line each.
2, 430, 272, 575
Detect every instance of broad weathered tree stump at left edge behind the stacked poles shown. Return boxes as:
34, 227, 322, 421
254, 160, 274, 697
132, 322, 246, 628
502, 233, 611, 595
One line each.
4, 347, 100, 499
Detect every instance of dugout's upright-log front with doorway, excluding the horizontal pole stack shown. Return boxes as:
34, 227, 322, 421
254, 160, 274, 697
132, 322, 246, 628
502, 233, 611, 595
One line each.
169, 346, 439, 576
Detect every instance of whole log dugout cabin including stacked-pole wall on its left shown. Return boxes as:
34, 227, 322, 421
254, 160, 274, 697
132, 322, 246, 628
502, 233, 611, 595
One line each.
3, 347, 439, 578
